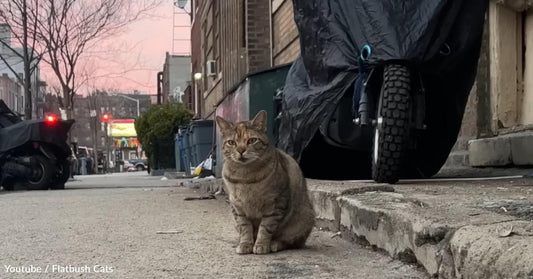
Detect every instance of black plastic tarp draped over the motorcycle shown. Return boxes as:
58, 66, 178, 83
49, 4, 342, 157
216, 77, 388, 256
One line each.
278, 0, 488, 176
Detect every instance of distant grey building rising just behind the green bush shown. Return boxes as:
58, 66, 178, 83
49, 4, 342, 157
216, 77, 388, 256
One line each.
162, 52, 191, 103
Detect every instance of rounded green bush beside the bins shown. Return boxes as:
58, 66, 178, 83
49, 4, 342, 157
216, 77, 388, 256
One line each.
135, 104, 194, 165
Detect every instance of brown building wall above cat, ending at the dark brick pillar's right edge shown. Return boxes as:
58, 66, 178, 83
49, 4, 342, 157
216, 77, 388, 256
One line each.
191, 0, 272, 119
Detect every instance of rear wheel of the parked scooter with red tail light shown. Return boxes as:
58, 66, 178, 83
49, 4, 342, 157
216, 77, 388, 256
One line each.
23, 155, 56, 190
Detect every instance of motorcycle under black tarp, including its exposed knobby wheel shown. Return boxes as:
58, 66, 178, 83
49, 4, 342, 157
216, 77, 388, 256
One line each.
278, 0, 488, 183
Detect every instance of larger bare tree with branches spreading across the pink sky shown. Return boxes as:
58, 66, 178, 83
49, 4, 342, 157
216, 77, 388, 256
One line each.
36, 0, 162, 118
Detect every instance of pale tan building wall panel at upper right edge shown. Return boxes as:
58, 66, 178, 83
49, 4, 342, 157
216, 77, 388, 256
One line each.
489, 1, 533, 131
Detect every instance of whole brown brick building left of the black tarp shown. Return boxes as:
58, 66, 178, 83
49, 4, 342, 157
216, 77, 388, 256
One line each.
190, 0, 299, 119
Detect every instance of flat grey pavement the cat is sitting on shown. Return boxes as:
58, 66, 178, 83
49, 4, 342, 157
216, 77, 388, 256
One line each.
0, 172, 426, 279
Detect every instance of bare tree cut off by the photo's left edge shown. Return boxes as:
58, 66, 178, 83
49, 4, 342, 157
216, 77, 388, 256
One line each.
0, 0, 43, 119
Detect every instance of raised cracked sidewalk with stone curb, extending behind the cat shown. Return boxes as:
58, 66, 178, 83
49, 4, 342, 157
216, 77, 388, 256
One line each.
181, 178, 533, 279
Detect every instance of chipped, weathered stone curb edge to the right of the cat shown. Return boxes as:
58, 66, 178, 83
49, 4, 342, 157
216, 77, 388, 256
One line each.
310, 186, 533, 279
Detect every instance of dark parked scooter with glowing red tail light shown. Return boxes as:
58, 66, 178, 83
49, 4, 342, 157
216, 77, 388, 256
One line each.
0, 100, 74, 190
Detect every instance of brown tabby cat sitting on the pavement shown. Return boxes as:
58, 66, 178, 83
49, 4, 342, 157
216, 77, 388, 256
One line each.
216, 111, 315, 254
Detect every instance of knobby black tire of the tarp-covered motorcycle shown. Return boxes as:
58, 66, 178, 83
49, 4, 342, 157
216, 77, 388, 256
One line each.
372, 64, 411, 184
